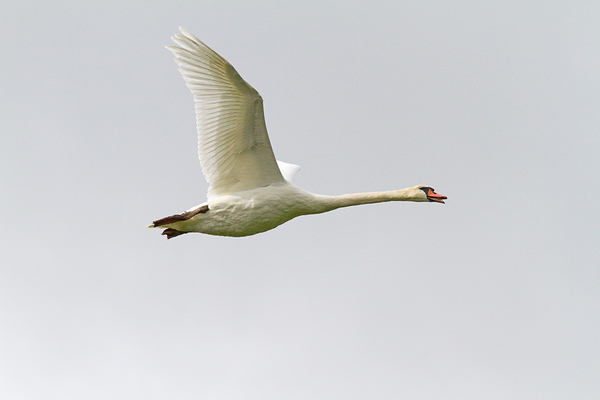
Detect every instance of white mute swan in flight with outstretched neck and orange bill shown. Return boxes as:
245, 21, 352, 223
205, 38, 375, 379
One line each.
149, 27, 446, 239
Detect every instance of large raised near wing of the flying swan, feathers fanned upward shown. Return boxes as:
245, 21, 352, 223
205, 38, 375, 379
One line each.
167, 27, 284, 198
